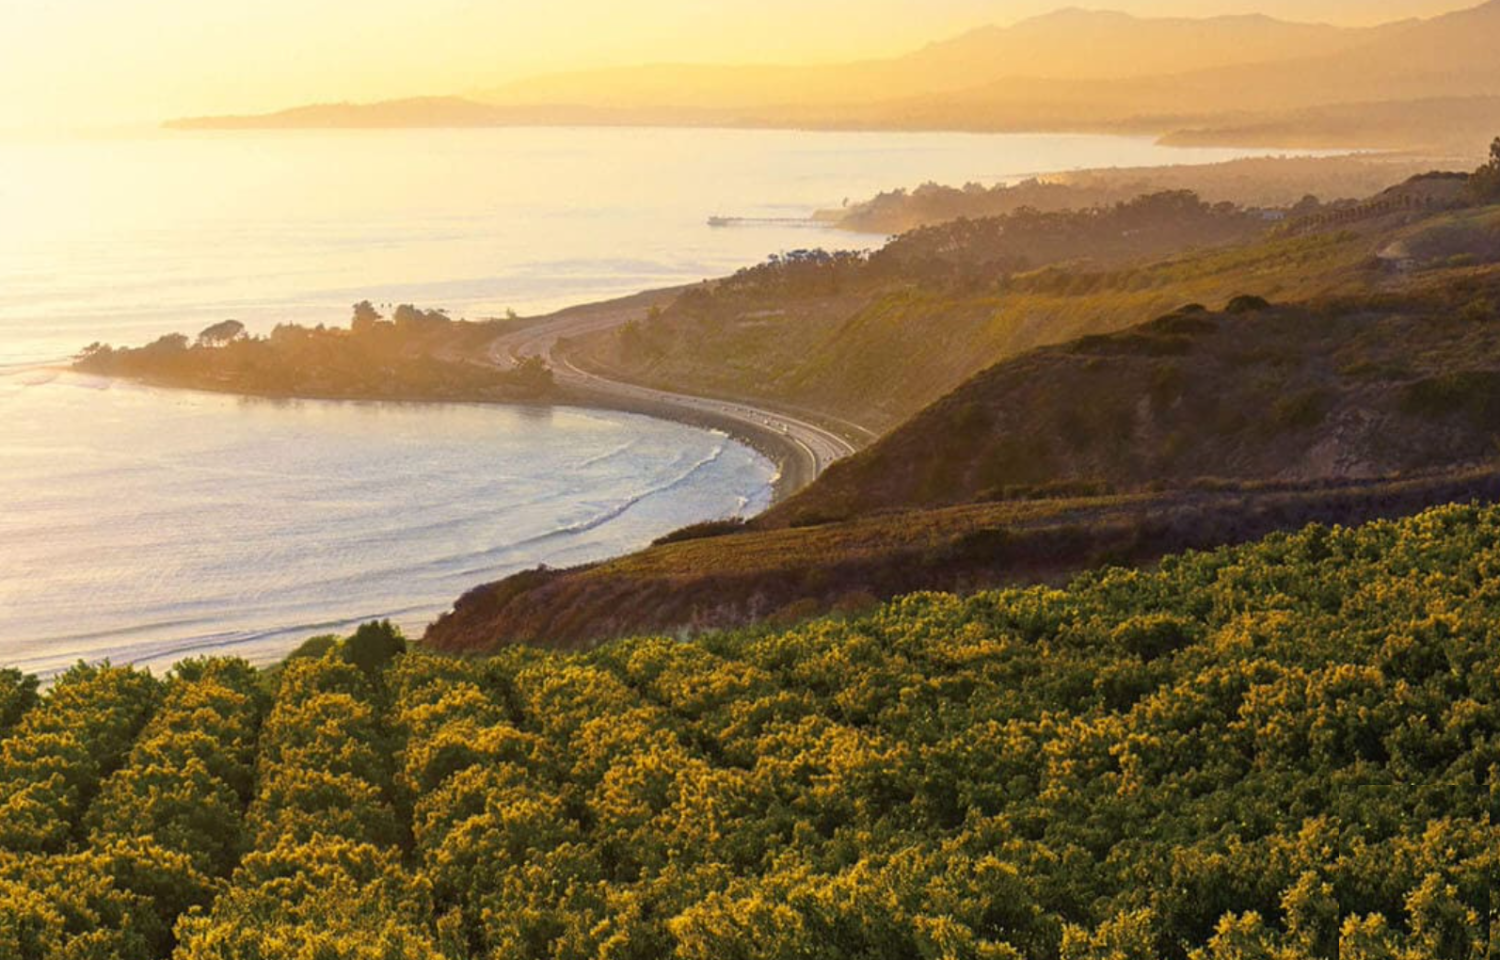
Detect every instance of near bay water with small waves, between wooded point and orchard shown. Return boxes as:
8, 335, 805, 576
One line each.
0, 367, 774, 674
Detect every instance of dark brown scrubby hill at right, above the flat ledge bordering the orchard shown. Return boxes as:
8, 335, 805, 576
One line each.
761, 270, 1500, 525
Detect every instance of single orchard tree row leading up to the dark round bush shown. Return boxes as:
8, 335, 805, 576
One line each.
176, 654, 441, 960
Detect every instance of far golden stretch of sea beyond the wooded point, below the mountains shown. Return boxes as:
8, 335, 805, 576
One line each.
0, 129, 1284, 365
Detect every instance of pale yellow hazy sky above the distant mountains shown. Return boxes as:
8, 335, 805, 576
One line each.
0, 0, 1479, 129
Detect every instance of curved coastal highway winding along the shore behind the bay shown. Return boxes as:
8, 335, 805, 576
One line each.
485, 294, 875, 498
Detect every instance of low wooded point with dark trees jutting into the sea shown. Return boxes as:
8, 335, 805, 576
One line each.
77, 302, 552, 399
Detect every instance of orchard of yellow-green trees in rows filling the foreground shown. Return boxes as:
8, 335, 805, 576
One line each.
0, 507, 1500, 960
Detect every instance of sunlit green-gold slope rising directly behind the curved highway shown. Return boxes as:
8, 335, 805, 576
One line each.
569, 195, 1455, 431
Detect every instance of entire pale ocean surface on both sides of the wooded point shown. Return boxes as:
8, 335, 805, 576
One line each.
0, 129, 1290, 674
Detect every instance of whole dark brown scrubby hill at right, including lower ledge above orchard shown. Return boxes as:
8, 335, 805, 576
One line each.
426, 186, 1500, 650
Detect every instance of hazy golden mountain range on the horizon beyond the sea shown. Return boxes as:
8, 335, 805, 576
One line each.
168, 0, 1500, 149
